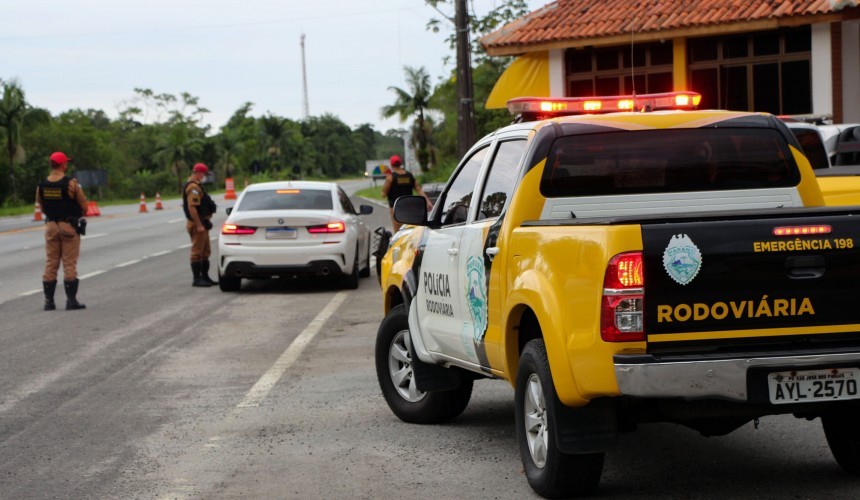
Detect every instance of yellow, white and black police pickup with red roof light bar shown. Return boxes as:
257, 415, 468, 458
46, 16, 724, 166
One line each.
376, 92, 860, 497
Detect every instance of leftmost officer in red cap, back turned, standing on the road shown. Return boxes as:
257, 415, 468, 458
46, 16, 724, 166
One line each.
36, 151, 87, 311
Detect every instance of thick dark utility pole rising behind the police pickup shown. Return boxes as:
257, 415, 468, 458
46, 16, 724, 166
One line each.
454, 0, 475, 157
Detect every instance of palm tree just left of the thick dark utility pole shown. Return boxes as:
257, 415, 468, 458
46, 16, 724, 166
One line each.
382, 66, 432, 172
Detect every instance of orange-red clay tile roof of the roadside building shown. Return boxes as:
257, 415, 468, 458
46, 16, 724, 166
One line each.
481, 0, 860, 53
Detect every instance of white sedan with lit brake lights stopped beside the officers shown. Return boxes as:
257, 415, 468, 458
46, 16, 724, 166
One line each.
218, 181, 373, 292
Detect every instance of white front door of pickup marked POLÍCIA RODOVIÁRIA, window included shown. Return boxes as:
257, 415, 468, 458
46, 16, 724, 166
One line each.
413, 147, 488, 355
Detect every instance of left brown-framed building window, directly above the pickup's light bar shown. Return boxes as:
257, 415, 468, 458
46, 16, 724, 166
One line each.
565, 42, 673, 97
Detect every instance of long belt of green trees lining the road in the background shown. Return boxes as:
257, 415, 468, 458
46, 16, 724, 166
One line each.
0, 0, 527, 209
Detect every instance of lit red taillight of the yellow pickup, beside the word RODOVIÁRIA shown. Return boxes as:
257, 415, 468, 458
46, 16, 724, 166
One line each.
600, 252, 645, 342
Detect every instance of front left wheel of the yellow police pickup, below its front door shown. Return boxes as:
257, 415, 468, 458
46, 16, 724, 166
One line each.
376, 304, 473, 424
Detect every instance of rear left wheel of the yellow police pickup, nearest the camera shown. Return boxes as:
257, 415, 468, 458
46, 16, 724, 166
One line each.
514, 339, 605, 498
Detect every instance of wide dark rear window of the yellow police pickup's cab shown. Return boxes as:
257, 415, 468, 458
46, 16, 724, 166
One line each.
540, 128, 800, 197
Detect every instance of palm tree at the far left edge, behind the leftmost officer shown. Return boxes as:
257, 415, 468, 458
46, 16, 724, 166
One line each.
0, 79, 51, 203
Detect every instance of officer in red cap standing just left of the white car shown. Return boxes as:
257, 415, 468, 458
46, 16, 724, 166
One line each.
182, 163, 217, 286
